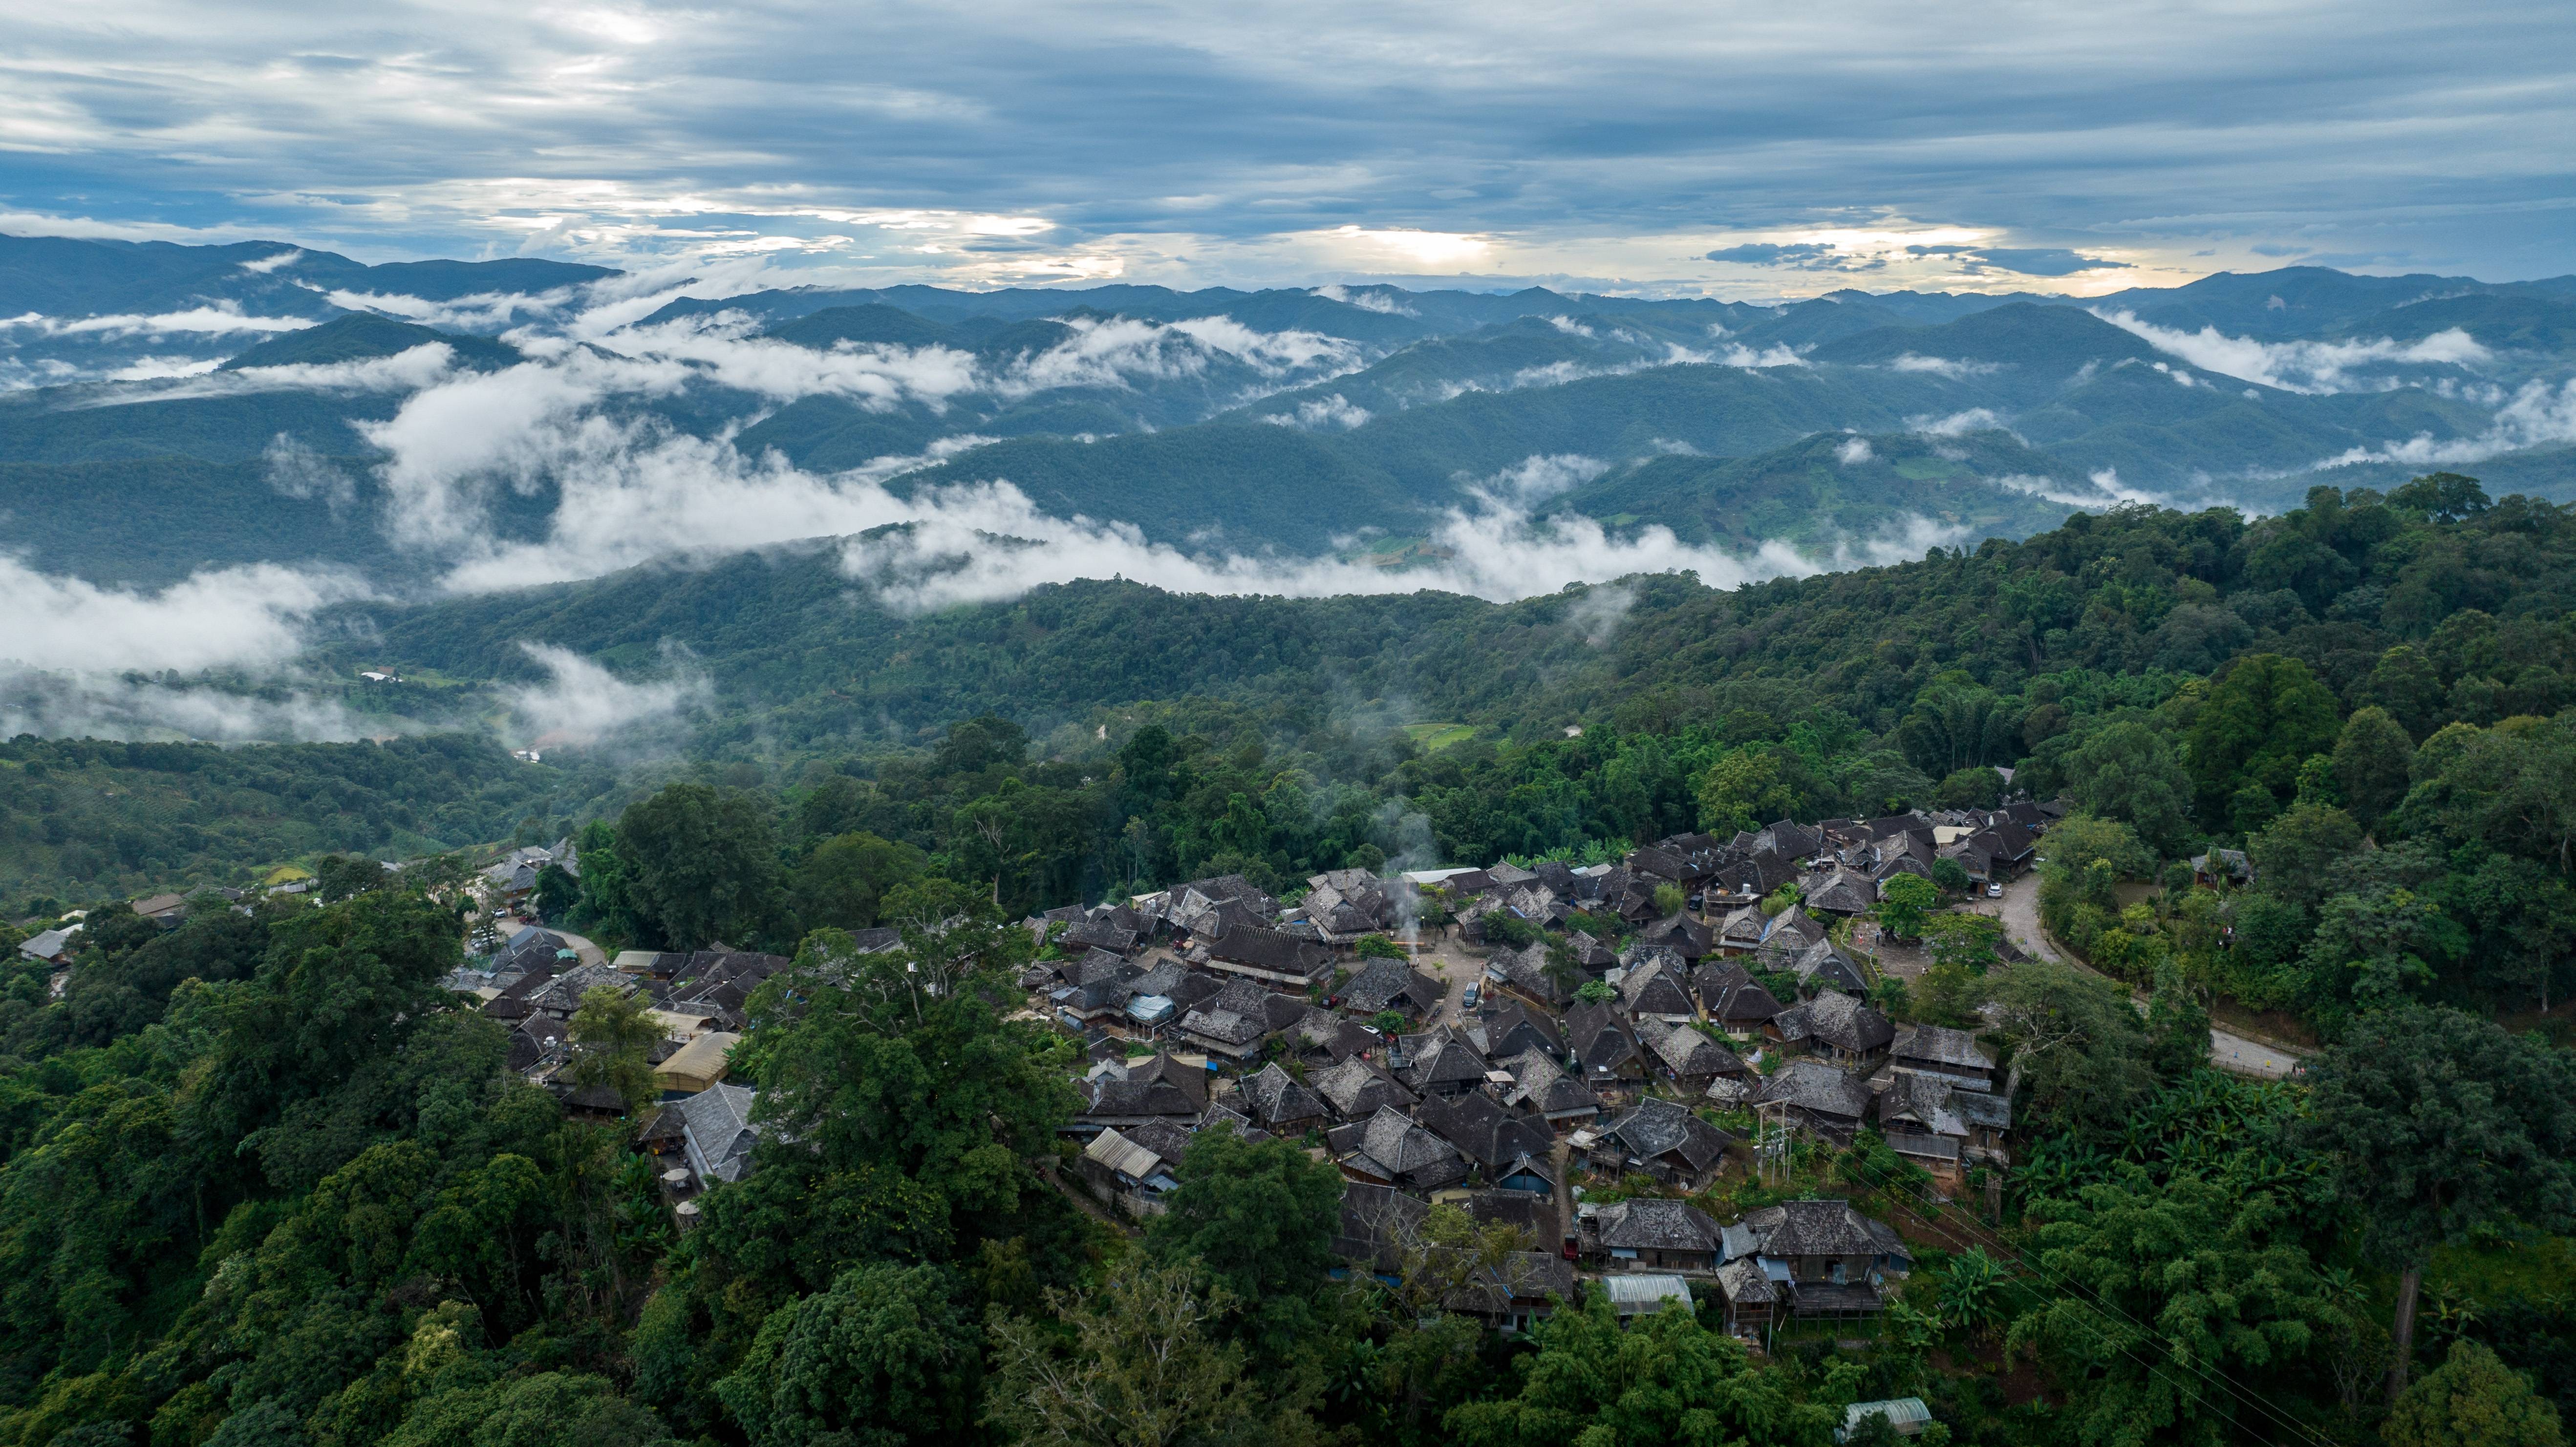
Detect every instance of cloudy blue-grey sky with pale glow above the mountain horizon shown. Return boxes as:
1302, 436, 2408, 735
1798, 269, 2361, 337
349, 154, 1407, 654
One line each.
0, 0, 2576, 296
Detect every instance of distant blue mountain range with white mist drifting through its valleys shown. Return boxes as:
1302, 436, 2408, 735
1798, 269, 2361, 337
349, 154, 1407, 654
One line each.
0, 237, 2576, 590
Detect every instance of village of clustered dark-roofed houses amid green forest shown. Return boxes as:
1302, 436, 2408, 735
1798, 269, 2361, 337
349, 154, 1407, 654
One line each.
391, 801, 2063, 1339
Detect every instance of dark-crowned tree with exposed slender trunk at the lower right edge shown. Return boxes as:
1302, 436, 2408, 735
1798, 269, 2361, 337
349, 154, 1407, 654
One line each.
2298, 1004, 2576, 1401
